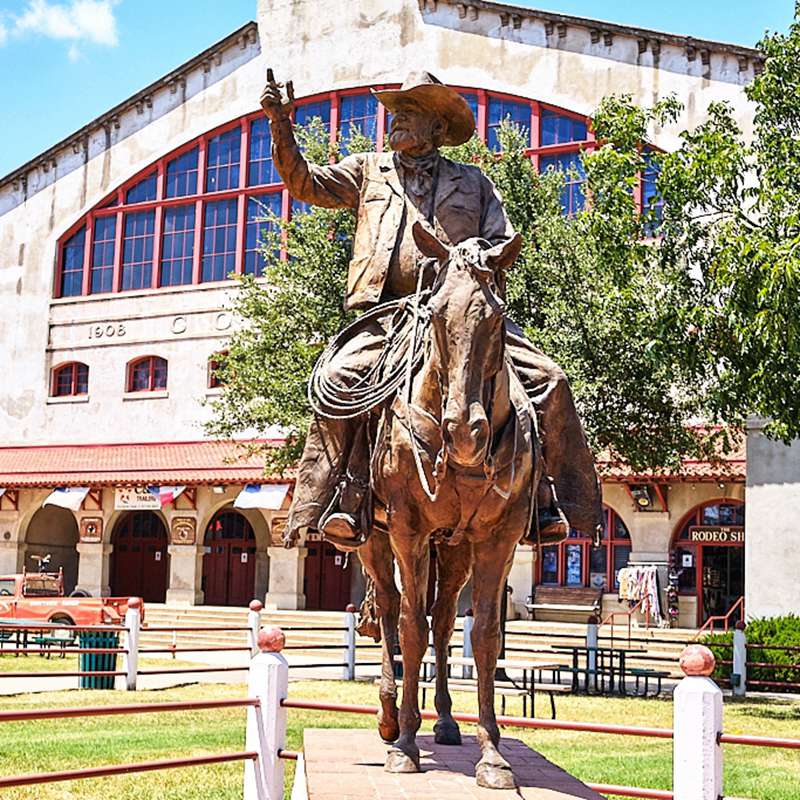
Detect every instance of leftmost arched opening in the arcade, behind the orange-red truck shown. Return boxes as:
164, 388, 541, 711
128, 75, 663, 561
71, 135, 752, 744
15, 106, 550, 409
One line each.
25, 506, 78, 594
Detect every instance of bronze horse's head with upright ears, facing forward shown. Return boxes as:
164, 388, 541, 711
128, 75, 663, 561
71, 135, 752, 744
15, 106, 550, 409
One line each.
413, 222, 522, 467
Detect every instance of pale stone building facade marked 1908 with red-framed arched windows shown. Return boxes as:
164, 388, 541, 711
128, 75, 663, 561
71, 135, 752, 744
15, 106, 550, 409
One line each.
0, 0, 760, 626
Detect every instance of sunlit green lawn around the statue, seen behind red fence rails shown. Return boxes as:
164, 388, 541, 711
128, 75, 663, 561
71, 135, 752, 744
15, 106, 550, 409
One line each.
0, 681, 800, 800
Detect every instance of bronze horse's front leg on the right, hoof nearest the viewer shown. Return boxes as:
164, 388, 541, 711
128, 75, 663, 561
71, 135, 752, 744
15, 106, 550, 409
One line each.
472, 537, 516, 789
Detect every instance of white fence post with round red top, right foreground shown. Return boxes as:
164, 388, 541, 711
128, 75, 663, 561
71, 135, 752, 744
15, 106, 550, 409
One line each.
672, 644, 723, 800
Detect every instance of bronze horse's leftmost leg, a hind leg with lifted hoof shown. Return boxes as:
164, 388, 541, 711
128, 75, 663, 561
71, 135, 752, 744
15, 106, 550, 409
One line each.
357, 531, 400, 742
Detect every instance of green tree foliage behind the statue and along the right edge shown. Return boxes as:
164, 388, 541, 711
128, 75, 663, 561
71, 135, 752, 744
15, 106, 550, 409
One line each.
209, 8, 800, 468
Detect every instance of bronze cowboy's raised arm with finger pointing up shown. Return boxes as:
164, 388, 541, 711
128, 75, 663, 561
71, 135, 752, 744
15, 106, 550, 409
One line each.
261, 69, 364, 209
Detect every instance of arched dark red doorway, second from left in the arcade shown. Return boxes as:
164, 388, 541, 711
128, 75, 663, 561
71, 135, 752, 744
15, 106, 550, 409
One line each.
111, 511, 169, 603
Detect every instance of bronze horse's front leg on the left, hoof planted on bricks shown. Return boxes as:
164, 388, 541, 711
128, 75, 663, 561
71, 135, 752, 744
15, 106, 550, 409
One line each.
385, 533, 430, 772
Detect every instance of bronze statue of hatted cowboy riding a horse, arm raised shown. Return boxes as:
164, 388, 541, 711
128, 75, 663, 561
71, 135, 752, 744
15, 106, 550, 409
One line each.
261, 71, 602, 788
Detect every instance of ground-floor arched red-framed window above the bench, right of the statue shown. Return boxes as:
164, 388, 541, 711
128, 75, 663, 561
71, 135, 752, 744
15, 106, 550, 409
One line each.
536, 506, 631, 592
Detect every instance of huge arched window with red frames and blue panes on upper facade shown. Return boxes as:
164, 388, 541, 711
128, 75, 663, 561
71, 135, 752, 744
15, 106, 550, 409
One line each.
54, 86, 649, 297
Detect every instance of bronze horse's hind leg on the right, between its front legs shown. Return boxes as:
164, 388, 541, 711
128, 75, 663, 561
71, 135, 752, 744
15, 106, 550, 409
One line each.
431, 538, 472, 744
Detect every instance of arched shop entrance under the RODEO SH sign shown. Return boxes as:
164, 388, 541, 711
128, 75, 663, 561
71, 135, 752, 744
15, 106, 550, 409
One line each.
673, 498, 744, 625
